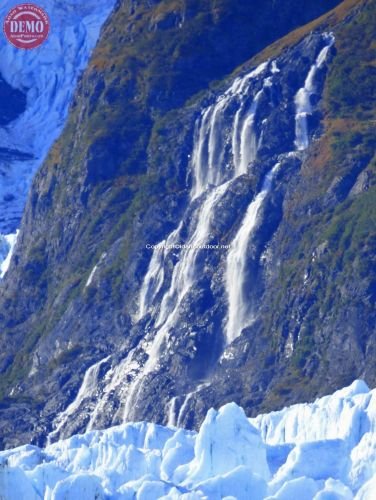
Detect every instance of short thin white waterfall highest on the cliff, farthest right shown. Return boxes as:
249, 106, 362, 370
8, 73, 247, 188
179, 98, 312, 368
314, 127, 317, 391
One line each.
295, 35, 334, 151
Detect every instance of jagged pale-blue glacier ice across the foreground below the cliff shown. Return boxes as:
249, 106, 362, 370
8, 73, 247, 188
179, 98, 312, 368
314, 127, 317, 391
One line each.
0, 380, 376, 500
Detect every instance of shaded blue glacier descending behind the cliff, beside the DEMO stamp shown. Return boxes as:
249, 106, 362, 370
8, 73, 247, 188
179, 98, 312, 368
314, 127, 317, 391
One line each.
0, 0, 115, 274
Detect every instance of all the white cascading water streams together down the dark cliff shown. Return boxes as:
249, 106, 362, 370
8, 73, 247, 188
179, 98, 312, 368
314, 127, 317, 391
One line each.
50, 35, 334, 436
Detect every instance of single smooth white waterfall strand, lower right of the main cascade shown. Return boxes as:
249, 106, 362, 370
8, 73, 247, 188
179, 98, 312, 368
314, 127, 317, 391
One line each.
226, 163, 281, 344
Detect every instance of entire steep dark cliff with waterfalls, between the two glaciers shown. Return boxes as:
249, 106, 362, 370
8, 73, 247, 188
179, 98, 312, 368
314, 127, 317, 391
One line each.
0, 0, 376, 446
